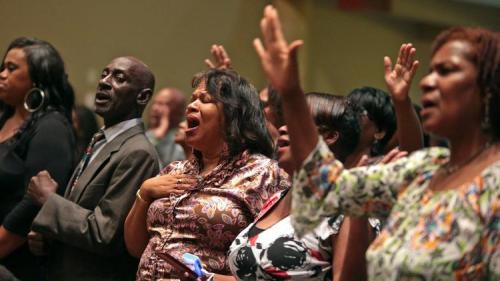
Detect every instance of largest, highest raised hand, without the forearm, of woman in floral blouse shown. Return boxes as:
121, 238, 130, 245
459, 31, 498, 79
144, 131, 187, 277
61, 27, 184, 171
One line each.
253, 5, 303, 96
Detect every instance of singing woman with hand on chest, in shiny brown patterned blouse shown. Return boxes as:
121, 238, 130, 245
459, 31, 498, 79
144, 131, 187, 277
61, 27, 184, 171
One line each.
125, 69, 290, 280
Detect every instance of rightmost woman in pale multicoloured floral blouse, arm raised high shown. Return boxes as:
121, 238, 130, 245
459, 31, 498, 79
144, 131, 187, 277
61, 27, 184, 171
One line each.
256, 4, 500, 280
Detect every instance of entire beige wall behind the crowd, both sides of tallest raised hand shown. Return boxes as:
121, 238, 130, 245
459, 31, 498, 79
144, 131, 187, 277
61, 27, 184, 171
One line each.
0, 0, 500, 109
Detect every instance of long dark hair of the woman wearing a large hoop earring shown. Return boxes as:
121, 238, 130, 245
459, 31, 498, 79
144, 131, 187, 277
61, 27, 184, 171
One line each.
0, 37, 75, 144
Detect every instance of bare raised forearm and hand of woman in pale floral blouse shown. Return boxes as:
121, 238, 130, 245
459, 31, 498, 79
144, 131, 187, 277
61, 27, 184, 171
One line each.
254, 5, 318, 169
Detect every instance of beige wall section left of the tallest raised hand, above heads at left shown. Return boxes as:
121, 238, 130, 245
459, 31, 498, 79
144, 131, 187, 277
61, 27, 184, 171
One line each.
0, 0, 266, 106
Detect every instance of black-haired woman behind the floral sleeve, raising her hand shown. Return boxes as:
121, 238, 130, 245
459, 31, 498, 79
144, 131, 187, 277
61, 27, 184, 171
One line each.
346, 43, 423, 164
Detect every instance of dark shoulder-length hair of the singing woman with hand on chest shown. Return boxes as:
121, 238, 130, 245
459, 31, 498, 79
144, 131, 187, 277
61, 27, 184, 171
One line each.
192, 69, 273, 157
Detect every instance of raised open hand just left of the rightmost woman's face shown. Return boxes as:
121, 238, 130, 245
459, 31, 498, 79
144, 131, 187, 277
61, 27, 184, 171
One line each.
384, 43, 419, 102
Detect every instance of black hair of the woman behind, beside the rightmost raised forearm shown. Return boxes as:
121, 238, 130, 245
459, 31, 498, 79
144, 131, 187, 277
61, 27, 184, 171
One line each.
347, 87, 397, 156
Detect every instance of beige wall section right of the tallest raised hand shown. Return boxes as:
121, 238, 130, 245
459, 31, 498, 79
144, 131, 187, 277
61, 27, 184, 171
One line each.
277, 0, 500, 99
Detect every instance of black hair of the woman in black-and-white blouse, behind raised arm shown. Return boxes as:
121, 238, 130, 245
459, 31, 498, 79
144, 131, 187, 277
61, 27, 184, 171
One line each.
306, 92, 361, 161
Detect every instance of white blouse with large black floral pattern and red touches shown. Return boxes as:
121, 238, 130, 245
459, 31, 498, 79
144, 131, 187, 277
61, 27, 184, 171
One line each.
228, 188, 344, 280
